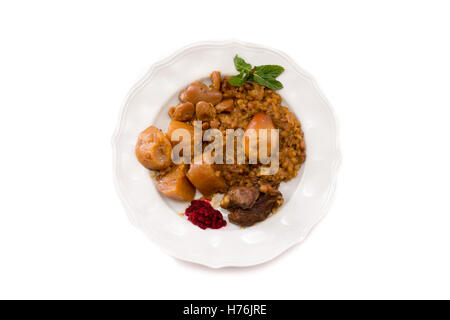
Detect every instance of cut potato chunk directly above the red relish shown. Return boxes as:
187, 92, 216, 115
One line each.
186, 163, 226, 196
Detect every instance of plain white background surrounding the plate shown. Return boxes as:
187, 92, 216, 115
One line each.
0, 0, 450, 299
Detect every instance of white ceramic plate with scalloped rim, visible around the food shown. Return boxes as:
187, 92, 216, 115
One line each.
113, 41, 340, 268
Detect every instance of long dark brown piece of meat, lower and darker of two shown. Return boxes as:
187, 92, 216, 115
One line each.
228, 190, 283, 227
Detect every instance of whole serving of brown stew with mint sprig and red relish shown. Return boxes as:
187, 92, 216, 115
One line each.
136, 56, 306, 229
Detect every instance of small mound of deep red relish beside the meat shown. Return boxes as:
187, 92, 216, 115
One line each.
184, 200, 227, 229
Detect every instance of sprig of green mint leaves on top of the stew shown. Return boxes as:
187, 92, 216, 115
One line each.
228, 55, 284, 90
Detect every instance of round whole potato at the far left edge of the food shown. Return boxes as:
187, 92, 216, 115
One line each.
135, 126, 172, 170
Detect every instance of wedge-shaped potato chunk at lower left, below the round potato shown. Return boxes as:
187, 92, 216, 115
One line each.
157, 164, 195, 201
